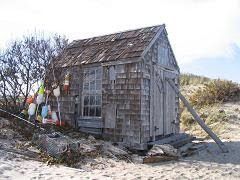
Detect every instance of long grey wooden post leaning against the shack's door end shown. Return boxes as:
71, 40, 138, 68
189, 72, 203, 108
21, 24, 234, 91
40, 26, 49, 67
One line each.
167, 79, 228, 153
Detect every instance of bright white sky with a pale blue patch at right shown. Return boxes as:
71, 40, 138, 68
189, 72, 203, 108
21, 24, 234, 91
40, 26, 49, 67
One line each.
0, 0, 240, 83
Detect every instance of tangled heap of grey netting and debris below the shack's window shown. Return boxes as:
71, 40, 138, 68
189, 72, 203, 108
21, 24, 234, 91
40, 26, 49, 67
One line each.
32, 132, 130, 167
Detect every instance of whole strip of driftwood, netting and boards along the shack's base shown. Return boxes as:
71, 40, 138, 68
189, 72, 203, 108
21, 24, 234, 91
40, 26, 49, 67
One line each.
0, 118, 206, 170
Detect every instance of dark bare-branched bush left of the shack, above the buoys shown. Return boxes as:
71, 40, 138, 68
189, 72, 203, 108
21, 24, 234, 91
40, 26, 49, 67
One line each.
0, 32, 68, 111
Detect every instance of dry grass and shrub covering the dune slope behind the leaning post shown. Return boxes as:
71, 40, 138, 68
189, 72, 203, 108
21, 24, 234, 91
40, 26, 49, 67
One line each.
180, 75, 240, 138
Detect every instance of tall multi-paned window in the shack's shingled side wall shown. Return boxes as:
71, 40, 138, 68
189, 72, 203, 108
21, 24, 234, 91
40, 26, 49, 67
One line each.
82, 68, 102, 117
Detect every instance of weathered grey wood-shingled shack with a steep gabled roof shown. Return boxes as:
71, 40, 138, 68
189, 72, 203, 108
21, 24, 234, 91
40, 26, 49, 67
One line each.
49, 25, 180, 149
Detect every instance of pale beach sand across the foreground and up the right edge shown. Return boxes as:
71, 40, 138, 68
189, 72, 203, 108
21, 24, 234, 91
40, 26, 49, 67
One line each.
0, 102, 240, 180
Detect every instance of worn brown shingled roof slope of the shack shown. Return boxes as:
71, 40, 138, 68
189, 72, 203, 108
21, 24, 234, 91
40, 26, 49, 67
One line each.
55, 25, 163, 67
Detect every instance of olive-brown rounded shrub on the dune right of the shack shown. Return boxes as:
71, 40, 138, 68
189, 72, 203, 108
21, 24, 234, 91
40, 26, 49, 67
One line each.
189, 79, 240, 108
